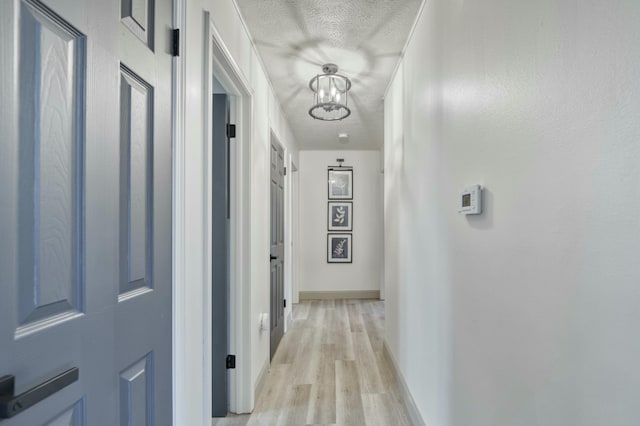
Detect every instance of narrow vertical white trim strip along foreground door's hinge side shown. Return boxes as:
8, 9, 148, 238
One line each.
171, 0, 187, 425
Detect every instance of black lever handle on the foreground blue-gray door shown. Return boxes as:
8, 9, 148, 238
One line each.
0, 367, 79, 419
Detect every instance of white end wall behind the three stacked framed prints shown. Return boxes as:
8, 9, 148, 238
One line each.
299, 150, 383, 292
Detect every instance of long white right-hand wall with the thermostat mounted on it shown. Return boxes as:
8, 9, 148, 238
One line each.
385, 0, 640, 426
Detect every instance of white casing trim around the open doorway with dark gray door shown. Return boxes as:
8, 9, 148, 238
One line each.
203, 11, 254, 417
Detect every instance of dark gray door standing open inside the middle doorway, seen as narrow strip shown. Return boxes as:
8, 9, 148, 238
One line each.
211, 94, 229, 417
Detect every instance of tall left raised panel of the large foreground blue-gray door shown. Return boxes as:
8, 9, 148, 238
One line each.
16, 3, 85, 336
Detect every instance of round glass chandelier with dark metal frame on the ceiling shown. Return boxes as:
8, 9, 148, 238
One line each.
309, 64, 351, 121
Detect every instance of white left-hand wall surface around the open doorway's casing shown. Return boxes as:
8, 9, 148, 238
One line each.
176, 0, 298, 425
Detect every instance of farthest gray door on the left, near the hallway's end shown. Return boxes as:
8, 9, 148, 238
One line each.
269, 141, 284, 358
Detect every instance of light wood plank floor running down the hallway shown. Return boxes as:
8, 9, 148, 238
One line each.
212, 300, 411, 426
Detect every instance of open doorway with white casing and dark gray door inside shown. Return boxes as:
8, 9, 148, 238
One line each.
203, 13, 254, 417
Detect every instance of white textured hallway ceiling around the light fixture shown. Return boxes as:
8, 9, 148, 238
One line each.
237, 0, 422, 149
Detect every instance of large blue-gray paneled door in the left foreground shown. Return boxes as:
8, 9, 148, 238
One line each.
0, 0, 172, 426
